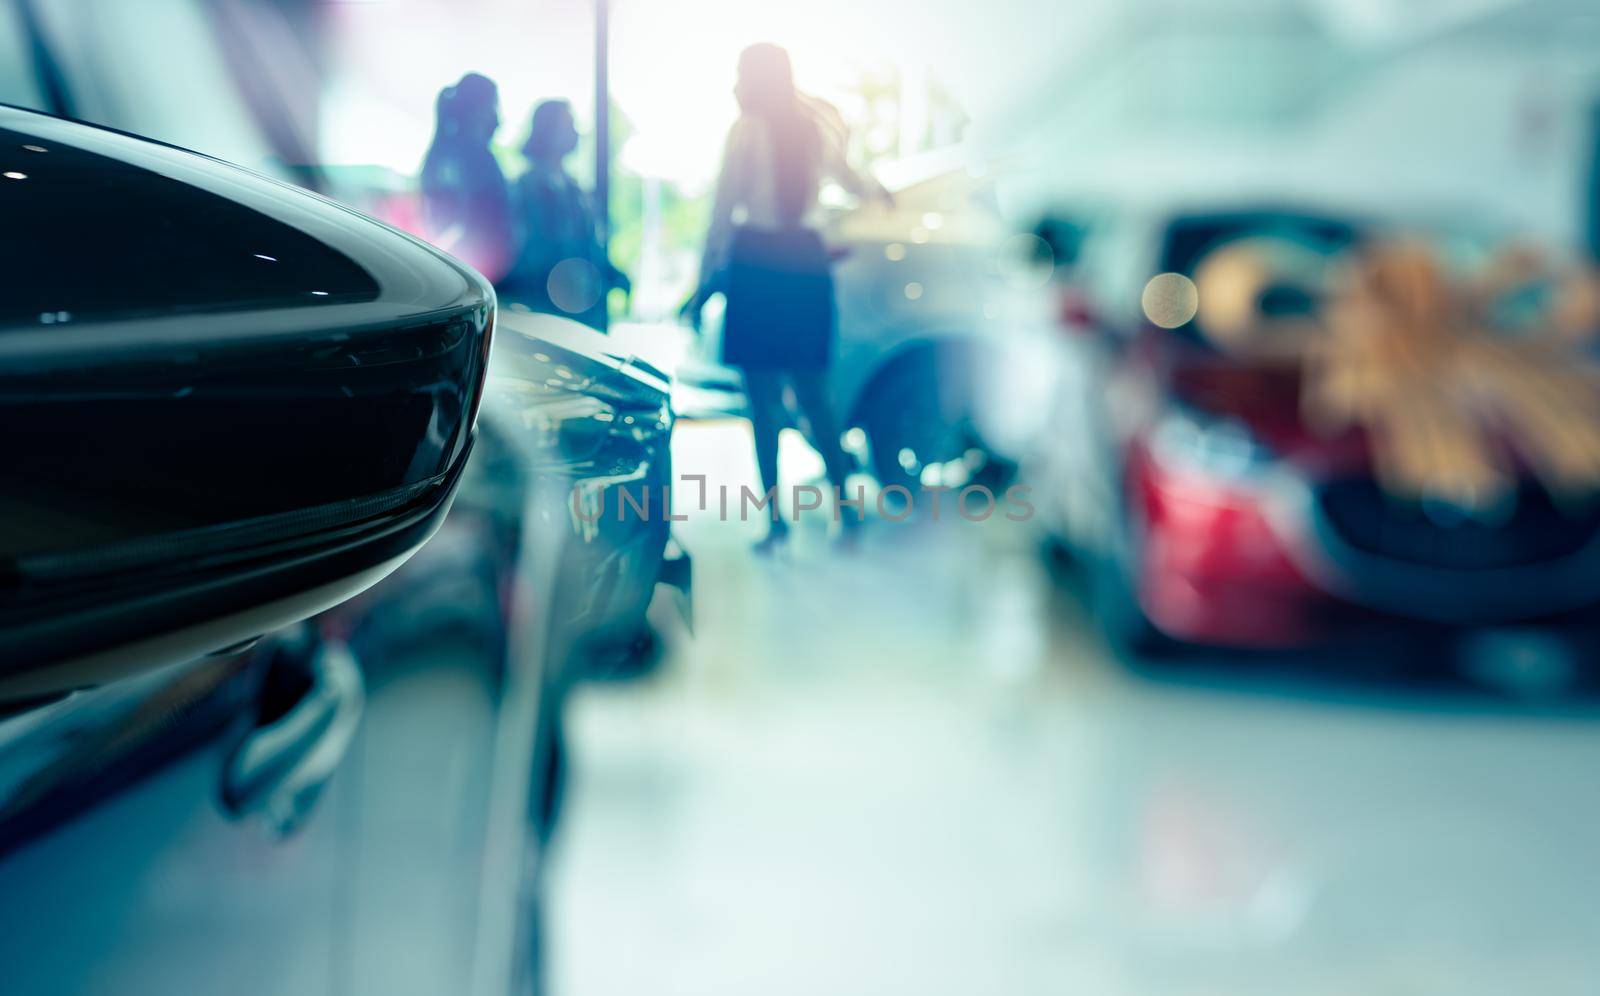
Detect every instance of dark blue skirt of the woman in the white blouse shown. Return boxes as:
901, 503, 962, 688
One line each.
722, 227, 834, 370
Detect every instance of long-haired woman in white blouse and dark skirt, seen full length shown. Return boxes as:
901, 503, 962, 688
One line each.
683, 43, 888, 552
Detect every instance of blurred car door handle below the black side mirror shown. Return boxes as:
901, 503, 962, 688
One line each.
222, 637, 366, 836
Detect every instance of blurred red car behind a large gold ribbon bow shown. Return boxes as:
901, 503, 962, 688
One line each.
1038, 207, 1600, 652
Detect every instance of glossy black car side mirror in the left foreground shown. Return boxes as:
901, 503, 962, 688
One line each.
0, 107, 494, 703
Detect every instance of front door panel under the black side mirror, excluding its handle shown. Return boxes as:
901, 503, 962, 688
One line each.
0, 652, 341, 994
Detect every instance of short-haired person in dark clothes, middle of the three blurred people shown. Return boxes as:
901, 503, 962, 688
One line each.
504, 101, 632, 331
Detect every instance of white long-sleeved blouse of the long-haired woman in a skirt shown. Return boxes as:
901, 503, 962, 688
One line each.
701, 107, 882, 282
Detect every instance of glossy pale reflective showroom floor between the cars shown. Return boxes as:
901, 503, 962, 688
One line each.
550, 421, 1600, 996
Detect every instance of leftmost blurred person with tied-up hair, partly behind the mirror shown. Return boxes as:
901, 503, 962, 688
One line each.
422, 72, 514, 280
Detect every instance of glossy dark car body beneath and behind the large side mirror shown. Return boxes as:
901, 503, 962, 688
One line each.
0, 305, 670, 996
